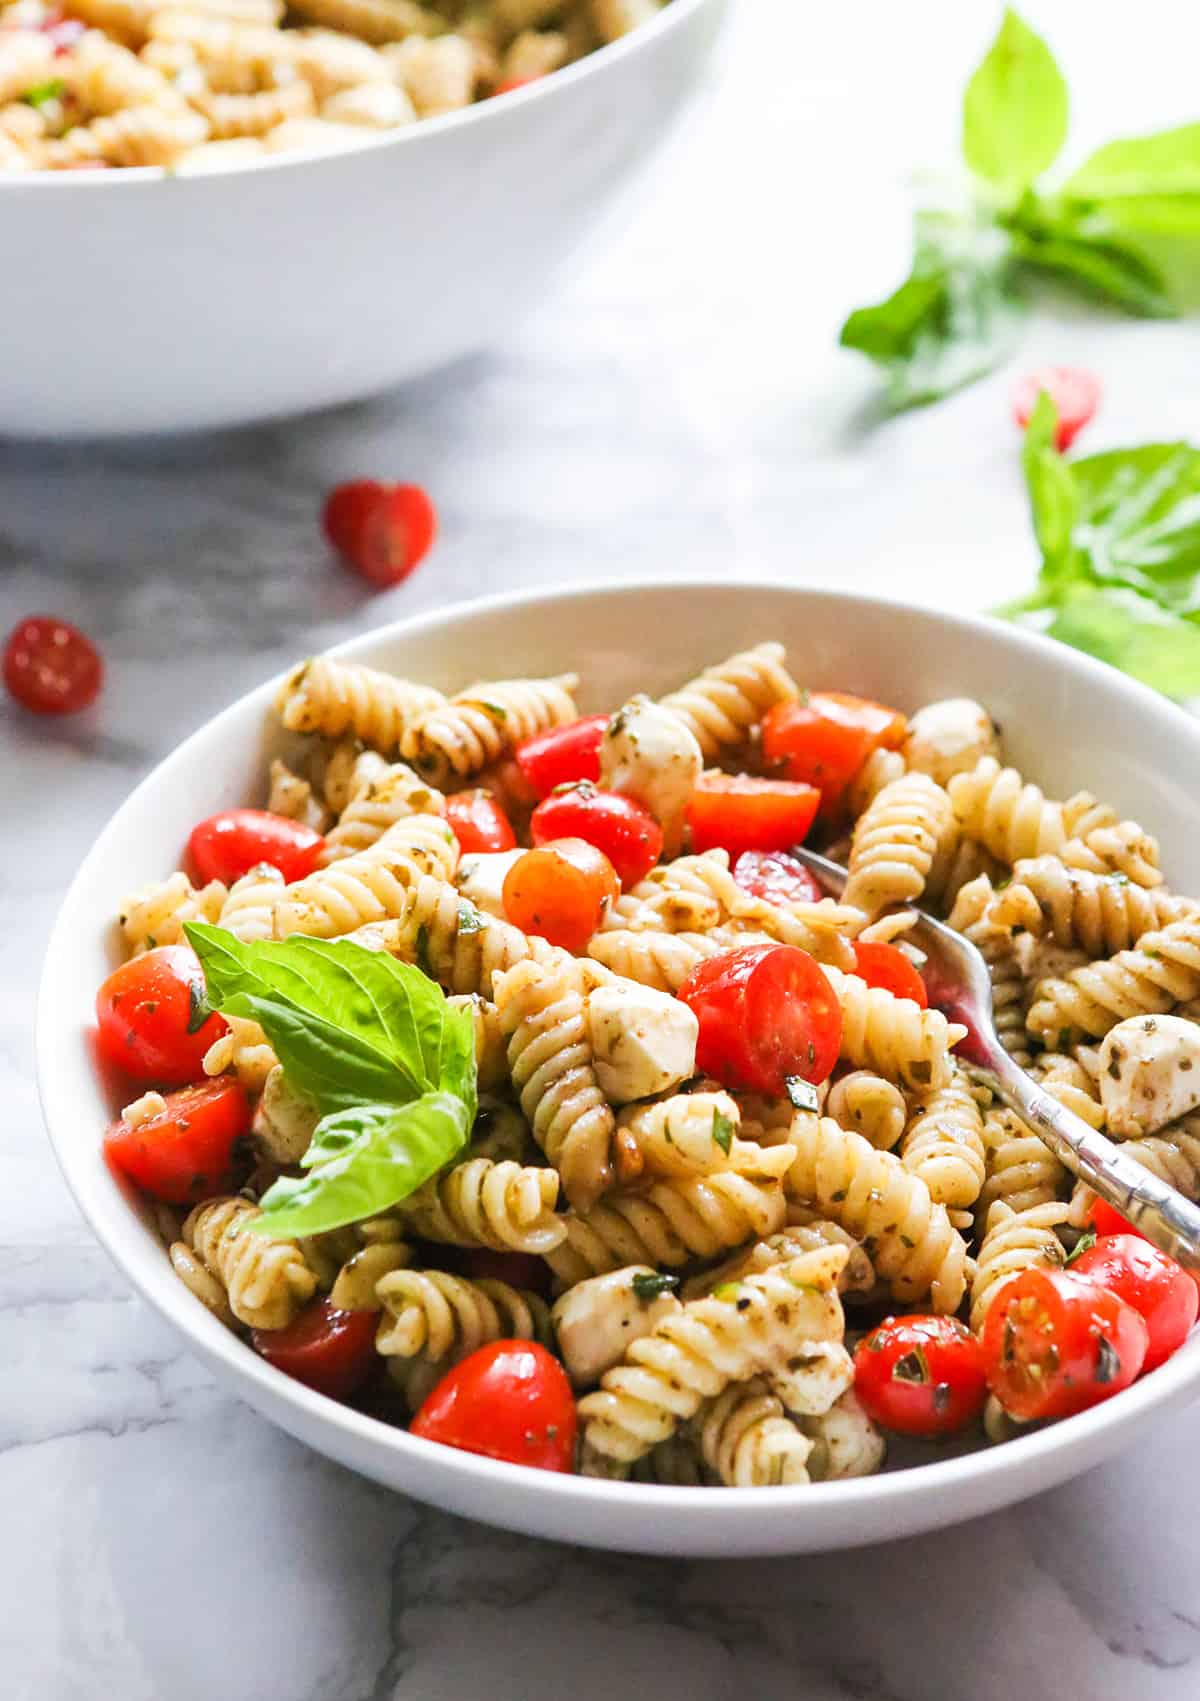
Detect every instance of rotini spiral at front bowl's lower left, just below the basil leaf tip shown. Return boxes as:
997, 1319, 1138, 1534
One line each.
182, 1198, 317, 1328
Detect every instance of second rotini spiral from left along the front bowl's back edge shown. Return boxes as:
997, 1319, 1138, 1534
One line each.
400, 674, 579, 786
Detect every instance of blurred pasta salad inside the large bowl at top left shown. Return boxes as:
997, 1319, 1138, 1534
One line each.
0, 0, 666, 175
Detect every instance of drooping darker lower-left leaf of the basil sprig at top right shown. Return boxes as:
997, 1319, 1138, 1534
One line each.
839, 211, 1023, 410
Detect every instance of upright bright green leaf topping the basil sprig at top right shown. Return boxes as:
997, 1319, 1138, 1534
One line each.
962, 10, 1067, 194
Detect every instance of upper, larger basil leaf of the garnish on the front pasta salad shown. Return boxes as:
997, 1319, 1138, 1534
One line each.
186, 922, 475, 1111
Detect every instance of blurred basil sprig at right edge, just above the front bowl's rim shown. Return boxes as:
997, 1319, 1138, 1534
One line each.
997, 393, 1200, 697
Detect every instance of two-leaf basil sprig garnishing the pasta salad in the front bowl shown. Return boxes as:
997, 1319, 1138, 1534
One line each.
186, 922, 477, 1238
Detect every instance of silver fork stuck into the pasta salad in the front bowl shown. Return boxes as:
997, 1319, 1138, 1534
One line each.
791, 845, 1200, 1272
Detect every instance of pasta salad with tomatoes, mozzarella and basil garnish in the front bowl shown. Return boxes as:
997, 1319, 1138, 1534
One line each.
97, 643, 1200, 1487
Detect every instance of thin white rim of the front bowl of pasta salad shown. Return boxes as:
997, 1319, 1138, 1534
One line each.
36, 577, 1200, 1551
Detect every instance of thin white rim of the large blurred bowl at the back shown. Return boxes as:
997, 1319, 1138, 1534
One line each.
0, 0, 713, 196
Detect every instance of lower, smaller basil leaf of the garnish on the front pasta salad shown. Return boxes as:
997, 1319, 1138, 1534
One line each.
254, 1092, 473, 1238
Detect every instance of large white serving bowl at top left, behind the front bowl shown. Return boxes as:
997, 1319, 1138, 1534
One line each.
0, 0, 727, 437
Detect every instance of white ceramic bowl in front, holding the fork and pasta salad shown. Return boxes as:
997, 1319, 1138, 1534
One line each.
37, 583, 1200, 1556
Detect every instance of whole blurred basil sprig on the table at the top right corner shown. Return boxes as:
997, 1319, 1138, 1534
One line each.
841, 10, 1200, 408
